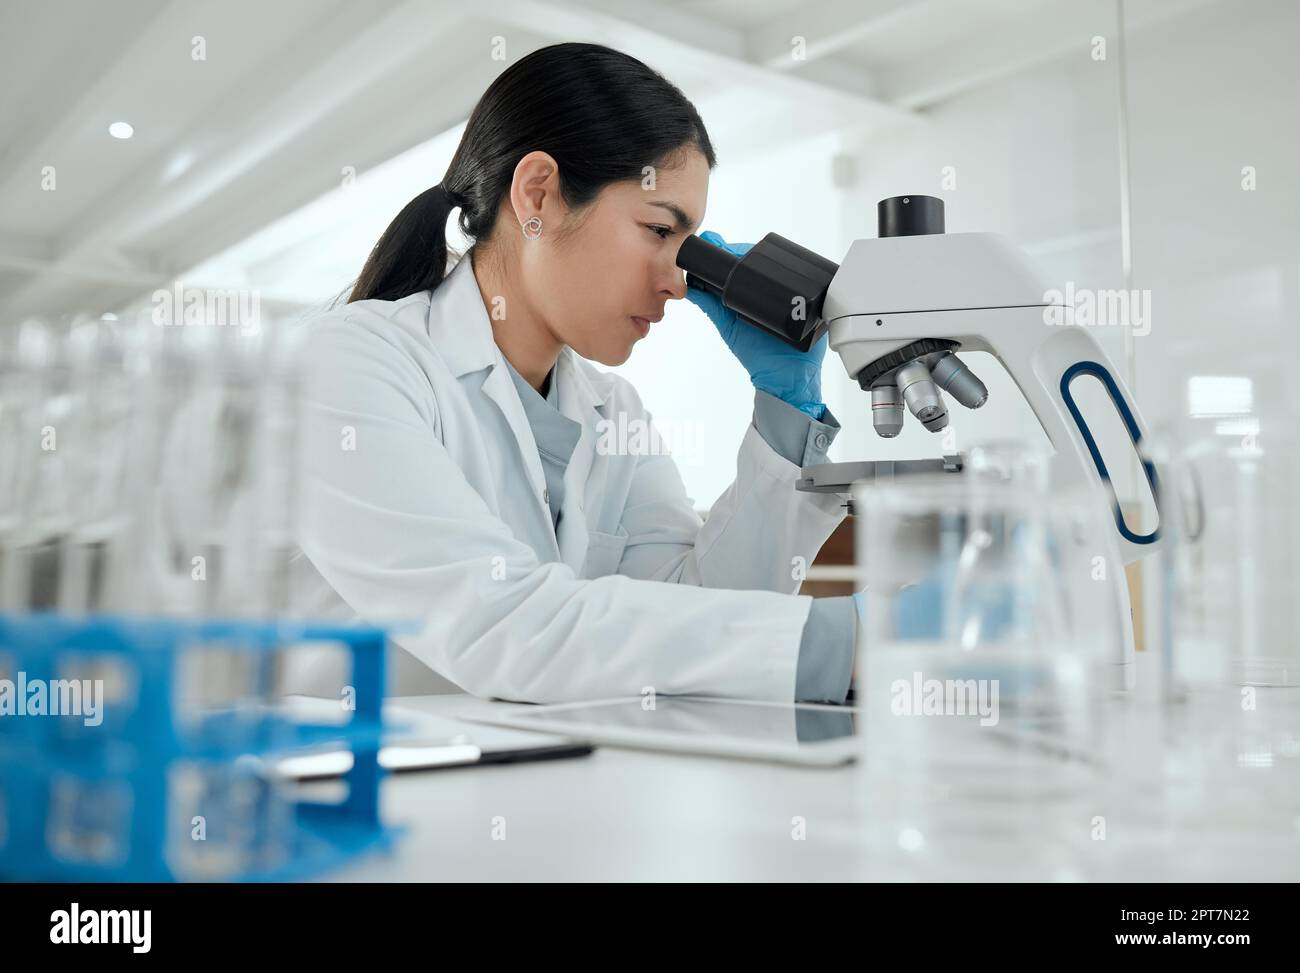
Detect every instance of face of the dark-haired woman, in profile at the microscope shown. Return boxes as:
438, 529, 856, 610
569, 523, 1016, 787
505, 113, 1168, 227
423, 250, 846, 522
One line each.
524, 151, 709, 366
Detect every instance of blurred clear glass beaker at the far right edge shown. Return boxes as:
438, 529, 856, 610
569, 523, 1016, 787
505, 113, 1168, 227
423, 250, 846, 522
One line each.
1152, 412, 1300, 831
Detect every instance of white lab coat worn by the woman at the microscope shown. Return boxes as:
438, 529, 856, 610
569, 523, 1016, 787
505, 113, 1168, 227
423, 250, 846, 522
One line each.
294, 258, 844, 702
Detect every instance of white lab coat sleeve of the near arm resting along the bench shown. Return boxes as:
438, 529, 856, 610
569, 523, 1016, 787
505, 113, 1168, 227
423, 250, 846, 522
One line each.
299, 317, 813, 702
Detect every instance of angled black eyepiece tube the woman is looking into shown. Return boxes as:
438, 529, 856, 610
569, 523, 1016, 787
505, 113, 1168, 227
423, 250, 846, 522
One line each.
677, 233, 840, 351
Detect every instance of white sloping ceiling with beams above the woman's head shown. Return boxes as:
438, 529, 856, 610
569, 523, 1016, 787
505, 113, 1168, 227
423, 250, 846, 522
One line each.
0, 0, 1206, 318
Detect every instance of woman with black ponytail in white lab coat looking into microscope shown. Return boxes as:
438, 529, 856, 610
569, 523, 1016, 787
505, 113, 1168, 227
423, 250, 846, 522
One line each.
295, 44, 857, 702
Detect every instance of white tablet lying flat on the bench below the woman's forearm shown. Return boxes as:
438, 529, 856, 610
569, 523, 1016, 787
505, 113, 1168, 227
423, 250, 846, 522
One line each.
464, 696, 861, 766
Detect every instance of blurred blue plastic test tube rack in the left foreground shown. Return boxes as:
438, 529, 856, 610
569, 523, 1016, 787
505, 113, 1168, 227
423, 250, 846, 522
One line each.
0, 613, 399, 882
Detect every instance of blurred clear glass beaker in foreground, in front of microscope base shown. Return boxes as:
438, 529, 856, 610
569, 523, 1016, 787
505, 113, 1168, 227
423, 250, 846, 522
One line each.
854, 475, 1119, 868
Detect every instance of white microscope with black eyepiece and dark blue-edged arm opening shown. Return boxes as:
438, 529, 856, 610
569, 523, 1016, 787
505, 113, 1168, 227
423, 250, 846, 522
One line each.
677, 196, 1160, 689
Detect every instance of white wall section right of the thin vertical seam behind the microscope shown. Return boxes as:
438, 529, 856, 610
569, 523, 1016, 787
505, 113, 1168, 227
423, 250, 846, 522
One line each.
1128, 0, 1300, 423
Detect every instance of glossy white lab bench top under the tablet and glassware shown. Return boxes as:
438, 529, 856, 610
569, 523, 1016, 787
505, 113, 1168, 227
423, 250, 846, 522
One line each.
332, 653, 1300, 882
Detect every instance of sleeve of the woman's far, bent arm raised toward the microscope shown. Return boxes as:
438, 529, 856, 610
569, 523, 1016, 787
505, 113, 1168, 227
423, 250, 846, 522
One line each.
619, 392, 845, 593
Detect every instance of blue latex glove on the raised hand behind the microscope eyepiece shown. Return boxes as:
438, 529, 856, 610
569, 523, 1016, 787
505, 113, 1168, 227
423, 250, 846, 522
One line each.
686, 230, 827, 420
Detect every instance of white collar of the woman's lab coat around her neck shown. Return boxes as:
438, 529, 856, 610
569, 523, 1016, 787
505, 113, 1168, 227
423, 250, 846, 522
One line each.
429, 254, 614, 408
